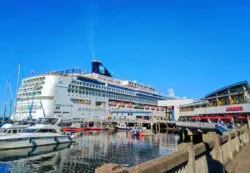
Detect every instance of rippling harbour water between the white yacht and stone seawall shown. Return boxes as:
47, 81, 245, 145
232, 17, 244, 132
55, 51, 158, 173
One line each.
0, 132, 178, 173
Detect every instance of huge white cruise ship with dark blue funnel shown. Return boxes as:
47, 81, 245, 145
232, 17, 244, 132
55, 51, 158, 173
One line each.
14, 60, 167, 120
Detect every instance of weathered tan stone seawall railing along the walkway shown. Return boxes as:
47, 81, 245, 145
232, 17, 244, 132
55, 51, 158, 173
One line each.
95, 127, 250, 173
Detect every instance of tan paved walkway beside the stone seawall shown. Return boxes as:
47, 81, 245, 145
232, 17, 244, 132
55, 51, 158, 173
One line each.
226, 143, 250, 173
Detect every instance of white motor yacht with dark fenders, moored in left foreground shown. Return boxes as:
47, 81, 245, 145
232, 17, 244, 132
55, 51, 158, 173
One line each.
0, 117, 72, 150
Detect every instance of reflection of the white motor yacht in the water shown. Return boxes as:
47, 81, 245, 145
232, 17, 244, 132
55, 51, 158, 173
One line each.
0, 143, 71, 162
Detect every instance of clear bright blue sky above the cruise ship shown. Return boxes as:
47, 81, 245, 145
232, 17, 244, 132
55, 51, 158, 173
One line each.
0, 0, 250, 113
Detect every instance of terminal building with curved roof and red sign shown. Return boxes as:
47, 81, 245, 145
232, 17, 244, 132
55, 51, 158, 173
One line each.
179, 81, 250, 121
